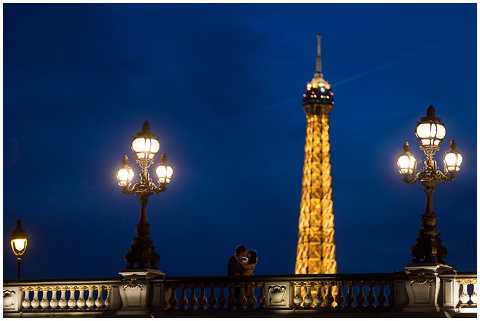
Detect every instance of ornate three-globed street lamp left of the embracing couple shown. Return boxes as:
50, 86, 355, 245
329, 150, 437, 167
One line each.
117, 121, 173, 269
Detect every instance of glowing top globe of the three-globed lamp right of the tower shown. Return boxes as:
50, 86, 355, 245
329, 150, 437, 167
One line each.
415, 106, 446, 151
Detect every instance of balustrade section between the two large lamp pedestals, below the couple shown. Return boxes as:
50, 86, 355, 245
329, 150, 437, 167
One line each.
153, 273, 405, 315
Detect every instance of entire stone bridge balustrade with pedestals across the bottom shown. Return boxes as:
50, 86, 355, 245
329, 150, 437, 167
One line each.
3, 272, 478, 317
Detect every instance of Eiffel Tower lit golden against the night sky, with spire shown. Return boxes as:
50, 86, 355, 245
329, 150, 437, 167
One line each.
295, 35, 337, 274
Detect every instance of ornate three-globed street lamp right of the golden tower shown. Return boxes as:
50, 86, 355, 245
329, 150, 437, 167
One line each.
397, 106, 462, 265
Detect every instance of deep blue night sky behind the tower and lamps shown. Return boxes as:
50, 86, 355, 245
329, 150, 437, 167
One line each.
3, 4, 477, 279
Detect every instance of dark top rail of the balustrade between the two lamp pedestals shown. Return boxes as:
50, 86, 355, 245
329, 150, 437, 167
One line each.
159, 272, 405, 283
